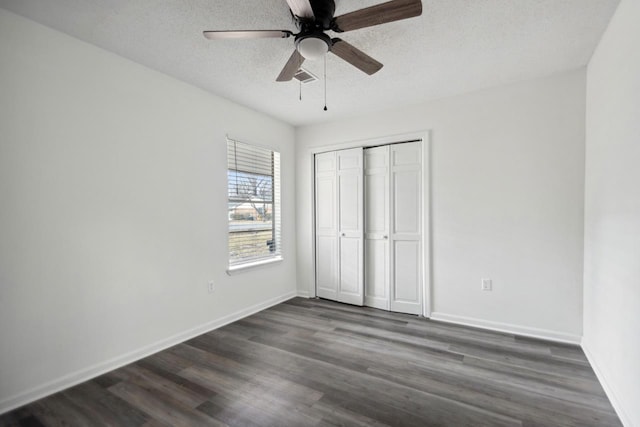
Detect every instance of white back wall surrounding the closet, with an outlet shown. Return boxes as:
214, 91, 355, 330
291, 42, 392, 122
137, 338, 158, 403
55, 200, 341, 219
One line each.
296, 70, 585, 342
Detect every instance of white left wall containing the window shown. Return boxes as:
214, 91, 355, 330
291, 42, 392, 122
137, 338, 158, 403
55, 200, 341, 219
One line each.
0, 9, 295, 412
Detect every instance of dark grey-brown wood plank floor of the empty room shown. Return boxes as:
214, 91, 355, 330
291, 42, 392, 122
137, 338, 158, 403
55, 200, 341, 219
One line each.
0, 298, 621, 427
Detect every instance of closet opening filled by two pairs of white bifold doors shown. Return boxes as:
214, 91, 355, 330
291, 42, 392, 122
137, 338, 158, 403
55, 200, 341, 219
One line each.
314, 139, 427, 315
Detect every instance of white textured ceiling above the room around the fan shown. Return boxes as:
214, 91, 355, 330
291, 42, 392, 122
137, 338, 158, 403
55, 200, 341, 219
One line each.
0, 0, 619, 125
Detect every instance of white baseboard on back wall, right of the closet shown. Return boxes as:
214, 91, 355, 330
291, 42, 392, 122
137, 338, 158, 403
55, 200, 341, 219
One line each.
431, 311, 582, 345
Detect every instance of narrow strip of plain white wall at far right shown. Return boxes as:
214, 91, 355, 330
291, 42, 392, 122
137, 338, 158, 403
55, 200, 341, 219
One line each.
583, 0, 640, 426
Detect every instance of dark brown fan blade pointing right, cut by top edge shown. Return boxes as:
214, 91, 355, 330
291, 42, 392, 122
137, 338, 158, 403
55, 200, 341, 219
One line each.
332, 0, 422, 32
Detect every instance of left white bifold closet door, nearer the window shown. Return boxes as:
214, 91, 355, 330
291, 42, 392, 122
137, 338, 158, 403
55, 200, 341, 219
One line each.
315, 148, 364, 305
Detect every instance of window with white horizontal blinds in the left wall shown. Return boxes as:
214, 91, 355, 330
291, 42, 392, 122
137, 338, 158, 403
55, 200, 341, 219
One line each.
227, 139, 282, 269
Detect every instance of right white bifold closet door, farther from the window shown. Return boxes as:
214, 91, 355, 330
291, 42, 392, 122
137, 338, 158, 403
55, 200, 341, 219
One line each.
364, 142, 422, 314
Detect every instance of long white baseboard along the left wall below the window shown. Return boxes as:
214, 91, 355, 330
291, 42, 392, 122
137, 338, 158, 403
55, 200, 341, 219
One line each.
0, 292, 296, 415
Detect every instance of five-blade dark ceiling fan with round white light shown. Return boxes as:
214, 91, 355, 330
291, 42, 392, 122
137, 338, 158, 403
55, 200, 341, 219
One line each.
203, 0, 422, 82
